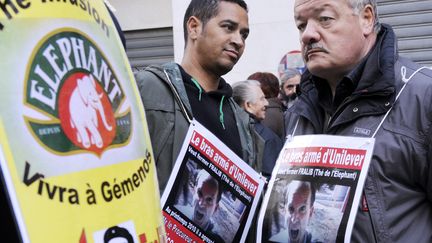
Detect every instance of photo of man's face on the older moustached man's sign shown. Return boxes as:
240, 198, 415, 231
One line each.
262, 177, 349, 243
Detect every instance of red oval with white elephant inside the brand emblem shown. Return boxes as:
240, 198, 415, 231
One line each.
60, 73, 116, 154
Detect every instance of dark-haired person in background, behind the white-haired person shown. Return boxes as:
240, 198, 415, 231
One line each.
247, 72, 285, 138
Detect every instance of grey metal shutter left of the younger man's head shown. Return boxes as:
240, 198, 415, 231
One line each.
124, 27, 174, 72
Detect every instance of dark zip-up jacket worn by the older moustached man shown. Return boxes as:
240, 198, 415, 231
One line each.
287, 25, 432, 243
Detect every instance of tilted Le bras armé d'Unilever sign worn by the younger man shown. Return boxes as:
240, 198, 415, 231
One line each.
161, 121, 265, 242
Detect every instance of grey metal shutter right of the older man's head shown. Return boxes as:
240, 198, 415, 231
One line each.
377, 0, 432, 66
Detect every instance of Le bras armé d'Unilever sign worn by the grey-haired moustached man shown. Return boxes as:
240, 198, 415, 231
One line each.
257, 135, 375, 242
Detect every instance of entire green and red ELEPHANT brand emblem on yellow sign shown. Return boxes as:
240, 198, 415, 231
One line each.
24, 29, 133, 157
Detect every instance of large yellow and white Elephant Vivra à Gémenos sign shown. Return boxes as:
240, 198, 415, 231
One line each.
0, 0, 165, 242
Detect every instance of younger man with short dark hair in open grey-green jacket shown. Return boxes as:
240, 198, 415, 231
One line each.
135, 0, 262, 193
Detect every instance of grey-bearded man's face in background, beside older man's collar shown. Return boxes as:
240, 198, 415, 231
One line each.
279, 68, 301, 111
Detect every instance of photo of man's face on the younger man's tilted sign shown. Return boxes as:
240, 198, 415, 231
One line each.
174, 156, 246, 242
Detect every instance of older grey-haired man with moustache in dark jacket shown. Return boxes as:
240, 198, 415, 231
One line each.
287, 0, 432, 243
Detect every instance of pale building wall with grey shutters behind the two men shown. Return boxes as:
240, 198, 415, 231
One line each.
109, 0, 432, 83
